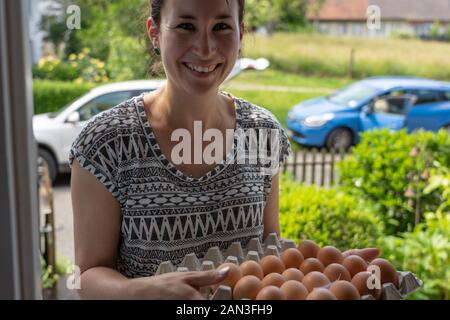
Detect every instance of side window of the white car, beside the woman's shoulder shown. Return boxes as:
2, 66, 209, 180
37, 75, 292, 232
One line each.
78, 91, 132, 121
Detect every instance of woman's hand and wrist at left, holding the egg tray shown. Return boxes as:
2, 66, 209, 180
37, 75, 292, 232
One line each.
129, 267, 230, 300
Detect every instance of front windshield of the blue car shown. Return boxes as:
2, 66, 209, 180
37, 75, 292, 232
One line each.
327, 83, 377, 108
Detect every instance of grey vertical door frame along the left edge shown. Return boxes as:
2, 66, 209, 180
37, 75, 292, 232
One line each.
0, 0, 42, 299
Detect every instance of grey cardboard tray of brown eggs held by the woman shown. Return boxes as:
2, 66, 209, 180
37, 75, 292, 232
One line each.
156, 234, 423, 300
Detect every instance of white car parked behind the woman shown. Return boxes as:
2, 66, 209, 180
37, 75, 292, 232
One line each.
33, 58, 269, 181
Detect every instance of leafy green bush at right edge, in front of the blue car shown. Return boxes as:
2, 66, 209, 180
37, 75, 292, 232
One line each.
338, 129, 450, 235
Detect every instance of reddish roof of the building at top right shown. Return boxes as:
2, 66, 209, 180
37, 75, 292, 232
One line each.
308, 0, 450, 22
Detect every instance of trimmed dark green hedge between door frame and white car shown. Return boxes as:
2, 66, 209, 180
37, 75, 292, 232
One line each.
33, 80, 94, 114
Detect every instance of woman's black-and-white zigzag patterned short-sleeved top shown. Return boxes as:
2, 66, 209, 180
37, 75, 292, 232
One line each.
70, 93, 290, 278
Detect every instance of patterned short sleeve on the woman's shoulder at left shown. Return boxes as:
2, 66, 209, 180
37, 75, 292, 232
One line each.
69, 114, 122, 201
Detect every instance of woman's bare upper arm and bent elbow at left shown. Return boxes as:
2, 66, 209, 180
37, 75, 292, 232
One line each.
71, 160, 128, 298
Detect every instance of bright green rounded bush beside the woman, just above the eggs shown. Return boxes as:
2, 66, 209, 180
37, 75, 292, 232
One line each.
279, 172, 383, 250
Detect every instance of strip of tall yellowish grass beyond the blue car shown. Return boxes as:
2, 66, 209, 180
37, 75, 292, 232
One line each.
244, 33, 450, 81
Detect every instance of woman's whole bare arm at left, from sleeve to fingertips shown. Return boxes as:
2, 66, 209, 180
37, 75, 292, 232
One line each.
71, 160, 227, 299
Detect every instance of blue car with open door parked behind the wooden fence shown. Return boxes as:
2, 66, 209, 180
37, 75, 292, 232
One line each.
286, 77, 450, 149
